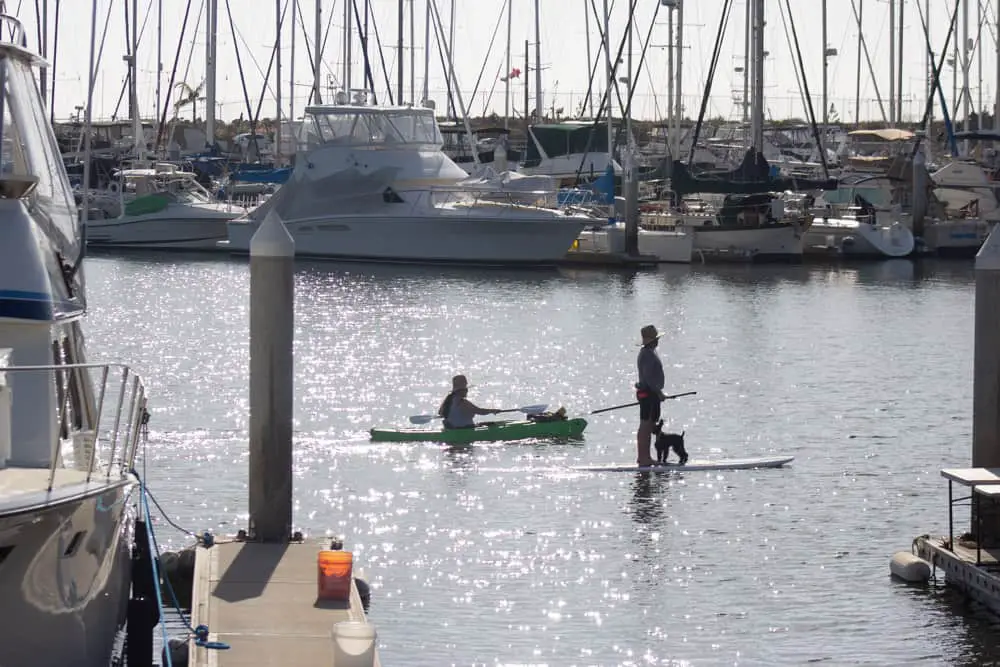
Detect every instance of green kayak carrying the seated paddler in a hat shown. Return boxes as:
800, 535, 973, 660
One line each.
371, 418, 587, 443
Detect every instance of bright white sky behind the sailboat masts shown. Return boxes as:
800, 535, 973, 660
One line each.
15, 0, 997, 121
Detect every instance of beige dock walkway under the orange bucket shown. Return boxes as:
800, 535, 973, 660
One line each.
189, 542, 379, 667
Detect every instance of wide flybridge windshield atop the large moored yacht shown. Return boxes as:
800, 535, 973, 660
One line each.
307, 107, 442, 148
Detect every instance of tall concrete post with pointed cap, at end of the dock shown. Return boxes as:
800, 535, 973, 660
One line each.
249, 210, 295, 542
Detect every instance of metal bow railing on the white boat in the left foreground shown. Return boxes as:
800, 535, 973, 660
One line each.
0, 363, 149, 491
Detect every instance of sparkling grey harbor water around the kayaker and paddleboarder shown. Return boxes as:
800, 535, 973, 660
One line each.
86, 255, 1000, 665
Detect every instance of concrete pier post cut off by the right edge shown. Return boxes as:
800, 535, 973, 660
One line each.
971, 225, 1000, 545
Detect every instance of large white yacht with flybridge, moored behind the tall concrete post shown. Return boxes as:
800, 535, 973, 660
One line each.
220, 105, 594, 265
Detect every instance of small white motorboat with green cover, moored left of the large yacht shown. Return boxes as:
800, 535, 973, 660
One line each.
87, 163, 247, 250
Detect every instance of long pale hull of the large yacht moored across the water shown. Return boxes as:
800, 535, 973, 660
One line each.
220, 212, 593, 265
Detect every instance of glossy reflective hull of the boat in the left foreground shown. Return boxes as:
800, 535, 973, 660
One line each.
0, 482, 135, 667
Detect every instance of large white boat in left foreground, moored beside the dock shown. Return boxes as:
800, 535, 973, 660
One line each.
0, 15, 145, 667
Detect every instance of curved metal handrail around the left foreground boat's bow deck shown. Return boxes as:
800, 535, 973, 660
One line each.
0, 363, 148, 491
